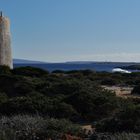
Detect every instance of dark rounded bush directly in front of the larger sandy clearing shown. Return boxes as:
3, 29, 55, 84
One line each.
65, 87, 117, 121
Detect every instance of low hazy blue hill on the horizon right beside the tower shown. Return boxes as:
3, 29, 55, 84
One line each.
13, 59, 45, 64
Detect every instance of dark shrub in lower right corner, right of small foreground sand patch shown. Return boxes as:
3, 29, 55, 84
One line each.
96, 105, 140, 133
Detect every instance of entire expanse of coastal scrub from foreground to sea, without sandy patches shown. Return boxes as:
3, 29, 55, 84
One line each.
0, 66, 140, 140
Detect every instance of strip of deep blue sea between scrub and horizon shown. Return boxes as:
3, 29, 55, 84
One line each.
14, 62, 138, 72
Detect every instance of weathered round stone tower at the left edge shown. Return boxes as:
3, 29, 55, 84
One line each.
0, 12, 13, 69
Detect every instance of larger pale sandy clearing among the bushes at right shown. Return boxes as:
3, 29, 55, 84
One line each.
103, 86, 140, 98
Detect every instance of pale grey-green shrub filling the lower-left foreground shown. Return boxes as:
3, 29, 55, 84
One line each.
0, 115, 81, 140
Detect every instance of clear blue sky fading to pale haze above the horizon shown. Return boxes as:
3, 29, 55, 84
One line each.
0, 0, 140, 62
